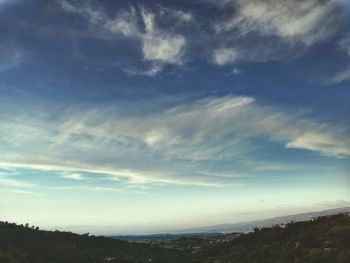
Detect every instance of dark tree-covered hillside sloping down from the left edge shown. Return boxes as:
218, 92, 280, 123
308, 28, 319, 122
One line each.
0, 222, 189, 263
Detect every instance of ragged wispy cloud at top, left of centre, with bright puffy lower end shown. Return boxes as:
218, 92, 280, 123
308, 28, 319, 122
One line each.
60, 1, 187, 76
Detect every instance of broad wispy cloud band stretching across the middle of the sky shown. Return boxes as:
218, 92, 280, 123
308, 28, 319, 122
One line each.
0, 96, 350, 186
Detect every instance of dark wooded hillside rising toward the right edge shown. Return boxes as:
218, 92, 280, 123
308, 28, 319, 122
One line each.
195, 214, 350, 263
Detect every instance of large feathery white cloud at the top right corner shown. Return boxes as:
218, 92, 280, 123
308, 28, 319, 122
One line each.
216, 0, 341, 45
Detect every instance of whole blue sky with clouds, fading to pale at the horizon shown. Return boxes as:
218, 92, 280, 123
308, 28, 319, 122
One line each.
0, 0, 350, 234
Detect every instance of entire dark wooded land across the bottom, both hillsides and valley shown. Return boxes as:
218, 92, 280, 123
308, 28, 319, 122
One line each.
0, 214, 350, 263
